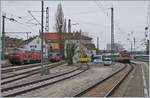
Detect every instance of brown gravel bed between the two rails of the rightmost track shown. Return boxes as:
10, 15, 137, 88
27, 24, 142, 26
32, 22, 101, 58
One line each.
81, 65, 131, 97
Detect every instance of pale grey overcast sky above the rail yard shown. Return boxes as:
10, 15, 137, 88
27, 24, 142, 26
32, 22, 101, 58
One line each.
1, 1, 149, 50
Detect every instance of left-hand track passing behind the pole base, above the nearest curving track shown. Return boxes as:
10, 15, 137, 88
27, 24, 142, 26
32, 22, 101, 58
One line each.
1, 61, 65, 85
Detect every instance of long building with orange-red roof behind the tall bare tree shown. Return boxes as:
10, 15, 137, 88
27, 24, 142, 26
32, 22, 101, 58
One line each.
40, 32, 96, 57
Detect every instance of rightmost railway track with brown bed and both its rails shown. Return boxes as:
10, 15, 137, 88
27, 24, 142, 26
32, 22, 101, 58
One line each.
74, 64, 133, 97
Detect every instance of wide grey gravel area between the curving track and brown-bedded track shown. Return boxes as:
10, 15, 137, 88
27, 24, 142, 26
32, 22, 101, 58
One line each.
20, 64, 124, 97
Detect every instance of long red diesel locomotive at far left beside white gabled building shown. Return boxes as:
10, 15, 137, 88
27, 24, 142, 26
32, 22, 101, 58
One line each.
9, 48, 42, 64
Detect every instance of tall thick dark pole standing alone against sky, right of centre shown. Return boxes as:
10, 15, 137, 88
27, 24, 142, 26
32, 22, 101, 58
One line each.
111, 7, 114, 57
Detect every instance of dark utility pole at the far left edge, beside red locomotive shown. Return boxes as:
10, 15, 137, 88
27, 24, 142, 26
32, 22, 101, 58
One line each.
1, 15, 6, 60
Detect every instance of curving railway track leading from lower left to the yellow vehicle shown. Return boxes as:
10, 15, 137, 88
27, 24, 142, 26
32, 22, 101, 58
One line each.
2, 64, 89, 97
